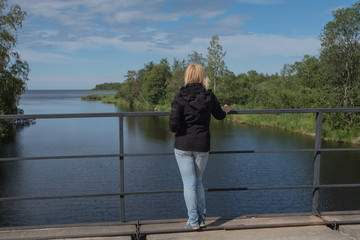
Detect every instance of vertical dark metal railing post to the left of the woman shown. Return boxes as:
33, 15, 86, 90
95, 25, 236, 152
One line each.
119, 114, 125, 222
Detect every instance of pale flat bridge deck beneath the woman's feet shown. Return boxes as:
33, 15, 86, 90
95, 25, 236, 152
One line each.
0, 211, 360, 240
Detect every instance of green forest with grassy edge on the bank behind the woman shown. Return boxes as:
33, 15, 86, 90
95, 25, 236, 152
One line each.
89, 2, 360, 143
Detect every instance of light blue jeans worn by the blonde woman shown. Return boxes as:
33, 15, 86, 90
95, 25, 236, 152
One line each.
174, 149, 209, 226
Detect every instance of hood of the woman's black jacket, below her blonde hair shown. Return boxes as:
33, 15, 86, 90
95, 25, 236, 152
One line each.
179, 83, 211, 112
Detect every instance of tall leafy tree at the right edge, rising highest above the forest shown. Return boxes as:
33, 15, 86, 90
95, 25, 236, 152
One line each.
320, 2, 360, 107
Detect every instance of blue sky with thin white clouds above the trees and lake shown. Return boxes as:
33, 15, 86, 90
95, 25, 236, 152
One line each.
8, 0, 357, 90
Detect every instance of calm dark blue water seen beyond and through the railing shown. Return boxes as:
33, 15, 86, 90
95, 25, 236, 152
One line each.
0, 90, 360, 226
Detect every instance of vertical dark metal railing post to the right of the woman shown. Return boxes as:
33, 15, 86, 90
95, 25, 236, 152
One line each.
312, 112, 322, 215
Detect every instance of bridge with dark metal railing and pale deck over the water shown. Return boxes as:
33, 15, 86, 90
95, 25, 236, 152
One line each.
0, 108, 360, 240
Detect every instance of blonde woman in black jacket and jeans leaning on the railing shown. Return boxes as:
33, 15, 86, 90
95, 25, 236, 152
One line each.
169, 64, 230, 230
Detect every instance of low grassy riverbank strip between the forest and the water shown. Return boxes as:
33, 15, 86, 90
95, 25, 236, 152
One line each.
81, 94, 360, 145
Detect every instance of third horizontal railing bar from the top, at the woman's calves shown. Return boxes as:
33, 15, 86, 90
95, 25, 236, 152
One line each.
0, 184, 360, 202
